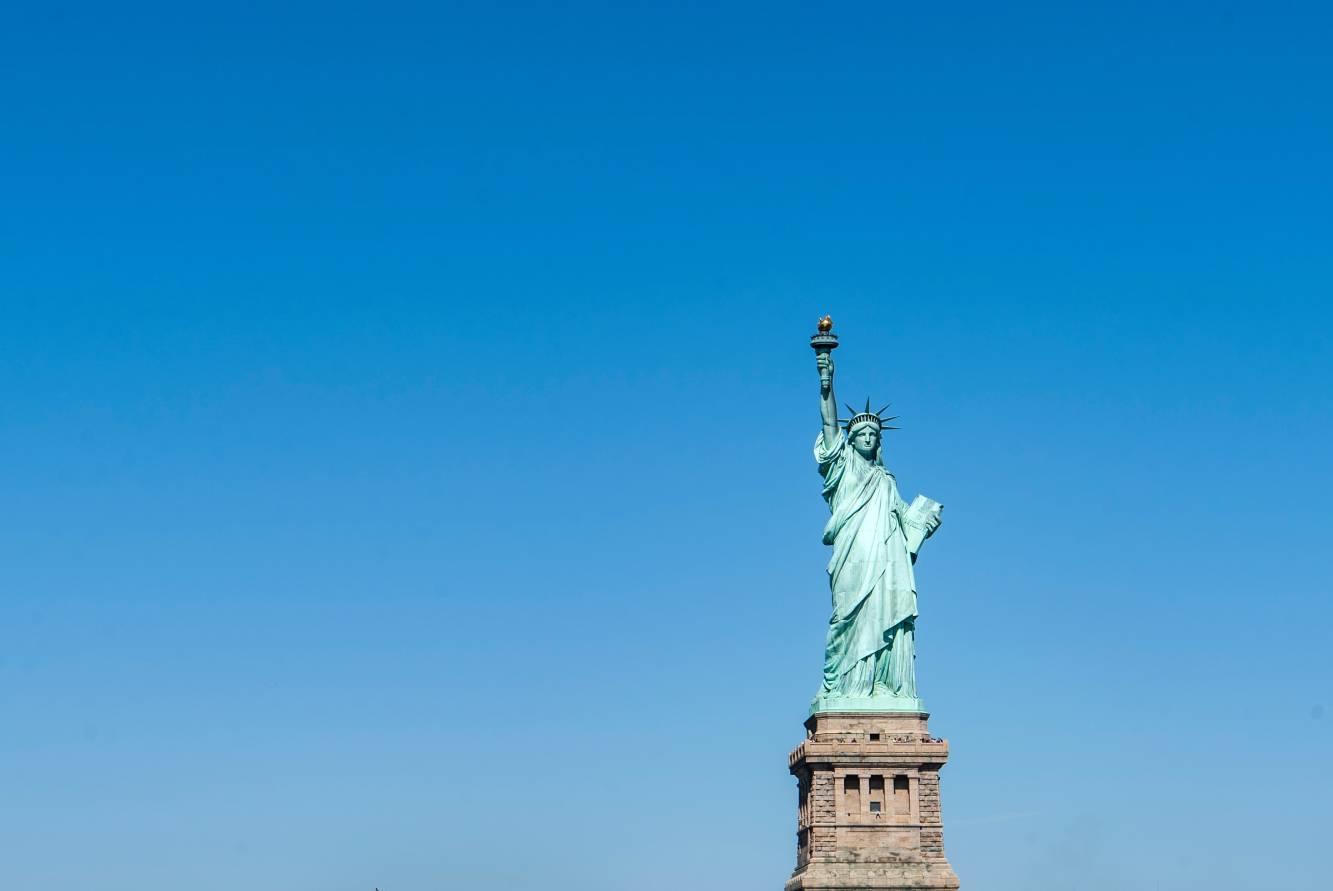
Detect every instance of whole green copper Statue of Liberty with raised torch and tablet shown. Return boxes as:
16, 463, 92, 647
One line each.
810, 316, 941, 714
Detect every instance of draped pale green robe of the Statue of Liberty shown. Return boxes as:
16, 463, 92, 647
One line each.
814, 431, 938, 698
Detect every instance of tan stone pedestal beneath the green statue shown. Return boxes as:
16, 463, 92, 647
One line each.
786, 712, 958, 891
